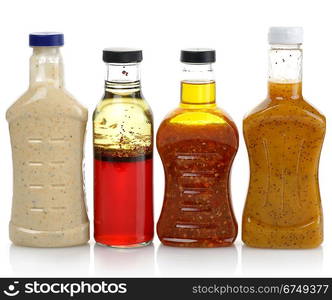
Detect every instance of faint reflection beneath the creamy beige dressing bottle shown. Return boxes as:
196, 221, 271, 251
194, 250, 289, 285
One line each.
9, 244, 90, 277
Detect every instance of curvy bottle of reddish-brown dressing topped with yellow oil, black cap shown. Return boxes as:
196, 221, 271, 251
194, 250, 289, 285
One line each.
157, 49, 239, 247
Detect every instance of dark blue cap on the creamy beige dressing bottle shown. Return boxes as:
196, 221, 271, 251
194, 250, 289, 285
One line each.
29, 32, 64, 47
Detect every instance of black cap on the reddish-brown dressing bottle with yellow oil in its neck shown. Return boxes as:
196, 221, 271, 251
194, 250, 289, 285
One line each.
181, 48, 216, 64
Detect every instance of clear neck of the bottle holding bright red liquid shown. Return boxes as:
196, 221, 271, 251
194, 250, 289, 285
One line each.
105, 63, 141, 96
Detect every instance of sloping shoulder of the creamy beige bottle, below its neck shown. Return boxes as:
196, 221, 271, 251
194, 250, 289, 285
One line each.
6, 85, 88, 122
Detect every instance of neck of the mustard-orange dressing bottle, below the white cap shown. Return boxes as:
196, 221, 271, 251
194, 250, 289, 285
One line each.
268, 45, 303, 100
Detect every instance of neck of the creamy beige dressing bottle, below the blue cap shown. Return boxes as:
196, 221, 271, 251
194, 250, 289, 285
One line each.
30, 47, 64, 88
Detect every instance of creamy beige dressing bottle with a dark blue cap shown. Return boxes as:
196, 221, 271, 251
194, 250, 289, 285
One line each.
7, 32, 89, 247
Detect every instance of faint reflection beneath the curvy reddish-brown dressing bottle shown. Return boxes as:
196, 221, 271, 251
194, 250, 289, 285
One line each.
157, 245, 238, 277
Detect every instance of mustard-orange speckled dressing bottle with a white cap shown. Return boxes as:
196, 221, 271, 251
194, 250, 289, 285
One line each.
242, 27, 326, 248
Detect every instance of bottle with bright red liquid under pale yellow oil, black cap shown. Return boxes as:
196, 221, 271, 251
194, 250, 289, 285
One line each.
93, 48, 153, 248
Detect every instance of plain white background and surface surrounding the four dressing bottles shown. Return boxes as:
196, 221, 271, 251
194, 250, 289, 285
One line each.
0, 0, 332, 277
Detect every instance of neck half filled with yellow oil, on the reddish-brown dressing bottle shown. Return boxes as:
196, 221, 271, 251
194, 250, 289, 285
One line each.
181, 64, 216, 108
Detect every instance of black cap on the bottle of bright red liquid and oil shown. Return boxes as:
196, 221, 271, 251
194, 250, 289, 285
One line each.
103, 48, 143, 64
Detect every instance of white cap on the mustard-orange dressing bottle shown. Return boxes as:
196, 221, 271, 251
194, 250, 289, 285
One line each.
268, 27, 303, 45
